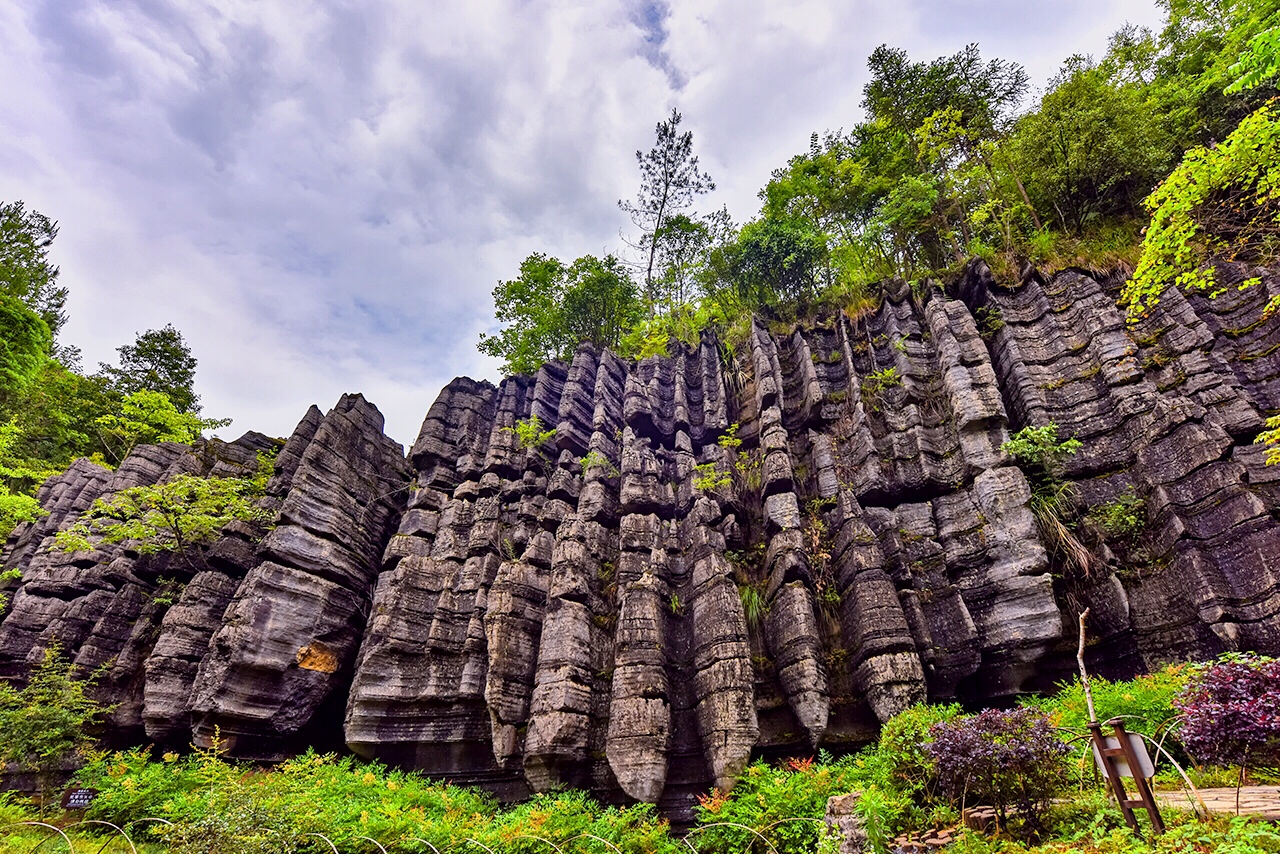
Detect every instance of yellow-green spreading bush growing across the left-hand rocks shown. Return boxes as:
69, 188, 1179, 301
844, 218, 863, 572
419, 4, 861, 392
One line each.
52, 474, 270, 557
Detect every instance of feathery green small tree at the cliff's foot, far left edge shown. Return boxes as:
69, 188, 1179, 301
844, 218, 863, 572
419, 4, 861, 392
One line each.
0, 644, 110, 802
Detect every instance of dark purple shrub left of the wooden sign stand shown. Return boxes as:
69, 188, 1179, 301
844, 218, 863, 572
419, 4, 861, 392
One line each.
925, 708, 1068, 832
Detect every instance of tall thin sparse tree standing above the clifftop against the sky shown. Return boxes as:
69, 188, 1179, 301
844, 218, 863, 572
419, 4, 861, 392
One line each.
618, 109, 716, 306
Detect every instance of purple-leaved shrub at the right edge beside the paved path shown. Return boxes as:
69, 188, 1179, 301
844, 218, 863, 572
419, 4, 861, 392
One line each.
1174, 654, 1280, 771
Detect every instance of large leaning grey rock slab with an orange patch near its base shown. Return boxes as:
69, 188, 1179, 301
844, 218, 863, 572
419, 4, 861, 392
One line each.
192, 394, 410, 758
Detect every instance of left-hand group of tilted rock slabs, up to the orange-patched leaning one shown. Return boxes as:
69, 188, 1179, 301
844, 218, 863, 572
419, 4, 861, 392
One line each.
0, 394, 410, 759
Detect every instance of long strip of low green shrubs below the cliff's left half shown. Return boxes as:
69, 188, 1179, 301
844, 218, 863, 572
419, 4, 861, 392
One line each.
78, 744, 678, 854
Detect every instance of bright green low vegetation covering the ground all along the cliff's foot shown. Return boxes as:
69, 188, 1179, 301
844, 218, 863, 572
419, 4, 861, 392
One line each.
0, 665, 1280, 854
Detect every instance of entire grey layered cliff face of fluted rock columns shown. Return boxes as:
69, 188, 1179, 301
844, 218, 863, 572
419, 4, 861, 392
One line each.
0, 265, 1280, 813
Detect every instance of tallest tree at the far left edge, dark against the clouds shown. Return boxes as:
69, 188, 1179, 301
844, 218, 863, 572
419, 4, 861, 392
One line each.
0, 201, 67, 338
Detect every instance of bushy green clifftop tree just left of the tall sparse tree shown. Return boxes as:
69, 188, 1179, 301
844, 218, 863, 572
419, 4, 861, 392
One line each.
480, 252, 640, 374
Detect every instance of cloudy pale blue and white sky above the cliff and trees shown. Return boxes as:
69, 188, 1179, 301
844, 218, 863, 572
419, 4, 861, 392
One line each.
0, 0, 1161, 444
